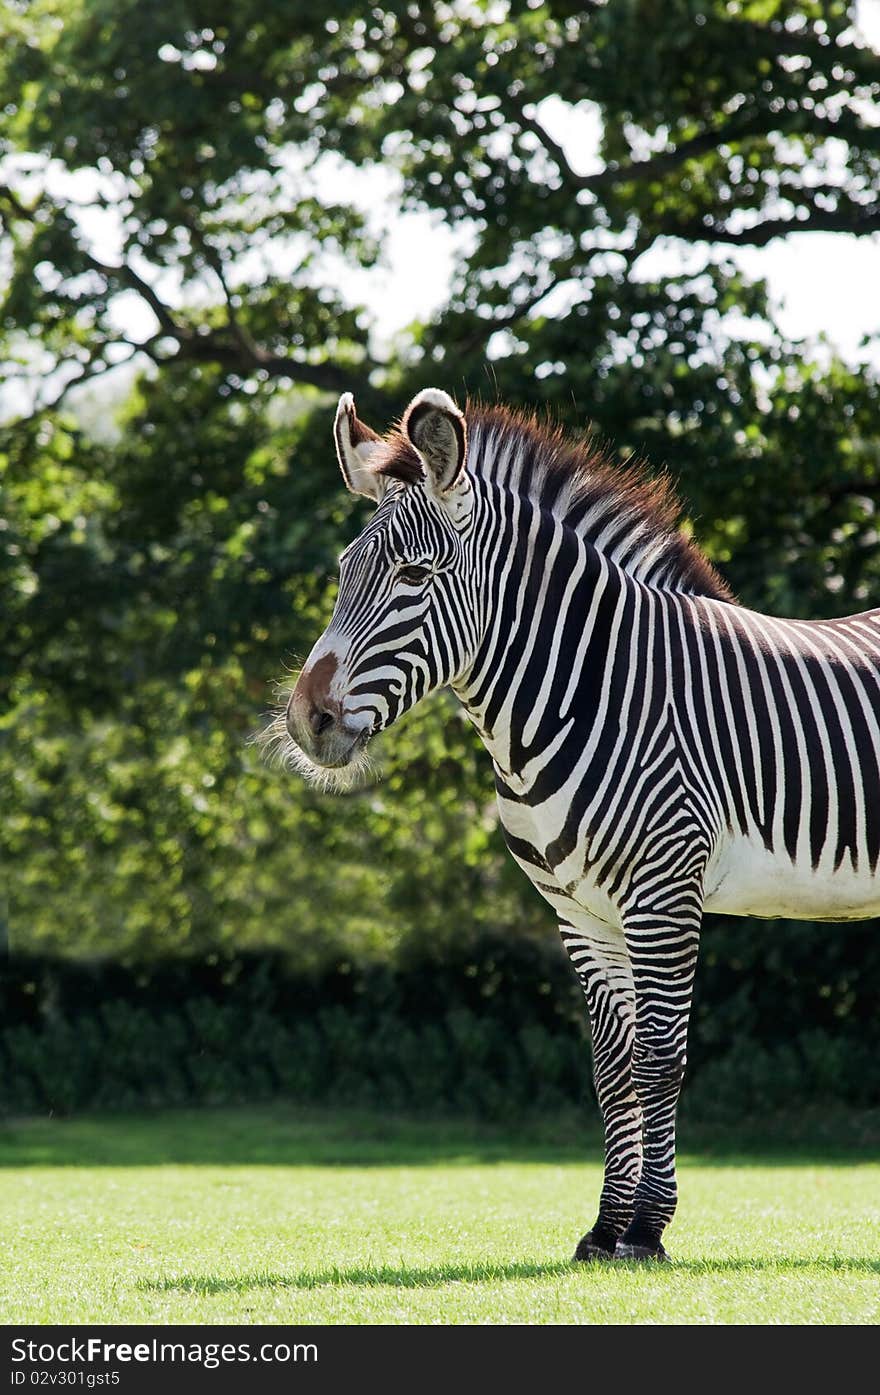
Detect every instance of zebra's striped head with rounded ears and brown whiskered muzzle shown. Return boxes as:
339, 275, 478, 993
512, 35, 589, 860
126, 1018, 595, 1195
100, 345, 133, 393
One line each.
276, 388, 480, 788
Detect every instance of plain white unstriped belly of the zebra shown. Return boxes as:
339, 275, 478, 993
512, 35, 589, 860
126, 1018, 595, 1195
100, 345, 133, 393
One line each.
704, 837, 880, 921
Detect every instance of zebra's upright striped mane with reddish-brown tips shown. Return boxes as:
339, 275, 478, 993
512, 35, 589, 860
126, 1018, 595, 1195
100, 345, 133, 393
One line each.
457, 407, 732, 601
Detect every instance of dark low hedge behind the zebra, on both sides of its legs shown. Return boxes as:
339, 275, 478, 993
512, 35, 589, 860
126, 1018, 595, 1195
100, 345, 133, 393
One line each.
0, 930, 880, 1126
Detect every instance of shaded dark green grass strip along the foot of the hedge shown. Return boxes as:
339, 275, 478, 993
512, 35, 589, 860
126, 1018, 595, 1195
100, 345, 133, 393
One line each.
0, 1103, 880, 1169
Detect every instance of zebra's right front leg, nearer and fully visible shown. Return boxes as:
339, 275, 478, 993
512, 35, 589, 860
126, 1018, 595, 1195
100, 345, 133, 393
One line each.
616, 889, 701, 1260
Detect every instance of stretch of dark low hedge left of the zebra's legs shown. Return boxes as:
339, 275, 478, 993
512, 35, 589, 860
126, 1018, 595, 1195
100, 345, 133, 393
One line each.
0, 940, 587, 1117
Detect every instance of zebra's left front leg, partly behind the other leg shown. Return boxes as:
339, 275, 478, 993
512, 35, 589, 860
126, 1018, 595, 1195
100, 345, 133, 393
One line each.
559, 915, 642, 1261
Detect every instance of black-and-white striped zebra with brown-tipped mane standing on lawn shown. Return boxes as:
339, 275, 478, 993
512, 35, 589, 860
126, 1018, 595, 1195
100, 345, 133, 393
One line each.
272, 388, 880, 1261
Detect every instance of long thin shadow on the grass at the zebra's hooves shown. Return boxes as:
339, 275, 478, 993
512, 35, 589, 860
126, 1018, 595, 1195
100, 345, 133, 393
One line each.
137, 1256, 880, 1297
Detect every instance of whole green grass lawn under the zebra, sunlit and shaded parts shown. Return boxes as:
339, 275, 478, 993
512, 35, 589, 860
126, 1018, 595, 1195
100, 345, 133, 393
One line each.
0, 1106, 880, 1324
